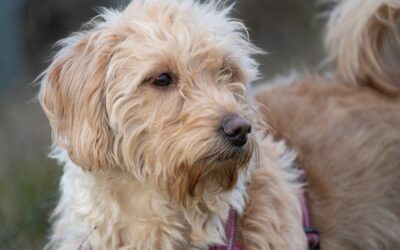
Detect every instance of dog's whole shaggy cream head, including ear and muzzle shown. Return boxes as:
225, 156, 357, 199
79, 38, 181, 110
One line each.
40, 0, 257, 202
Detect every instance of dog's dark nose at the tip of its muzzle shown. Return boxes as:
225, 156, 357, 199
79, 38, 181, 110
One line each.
221, 115, 251, 147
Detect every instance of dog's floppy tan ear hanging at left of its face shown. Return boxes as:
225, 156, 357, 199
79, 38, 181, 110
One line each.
39, 30, 119, 170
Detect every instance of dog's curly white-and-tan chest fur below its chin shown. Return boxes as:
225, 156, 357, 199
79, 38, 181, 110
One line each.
48, 146, 246, 249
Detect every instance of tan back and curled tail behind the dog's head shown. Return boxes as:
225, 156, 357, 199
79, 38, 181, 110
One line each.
257, 0, 400, 250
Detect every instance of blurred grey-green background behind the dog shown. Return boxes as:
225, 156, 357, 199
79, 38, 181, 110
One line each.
0, 0, 323, 249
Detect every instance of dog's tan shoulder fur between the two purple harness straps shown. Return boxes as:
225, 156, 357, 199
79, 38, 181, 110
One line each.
239, 166, 307, 250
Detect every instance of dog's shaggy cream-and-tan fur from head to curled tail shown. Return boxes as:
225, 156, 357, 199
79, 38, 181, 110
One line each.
39, 0, 400, 250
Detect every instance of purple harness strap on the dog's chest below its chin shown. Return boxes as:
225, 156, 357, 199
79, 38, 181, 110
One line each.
209, 208, 244, 250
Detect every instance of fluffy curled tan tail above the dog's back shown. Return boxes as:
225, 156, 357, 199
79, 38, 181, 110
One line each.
326, 0, 400, 95
